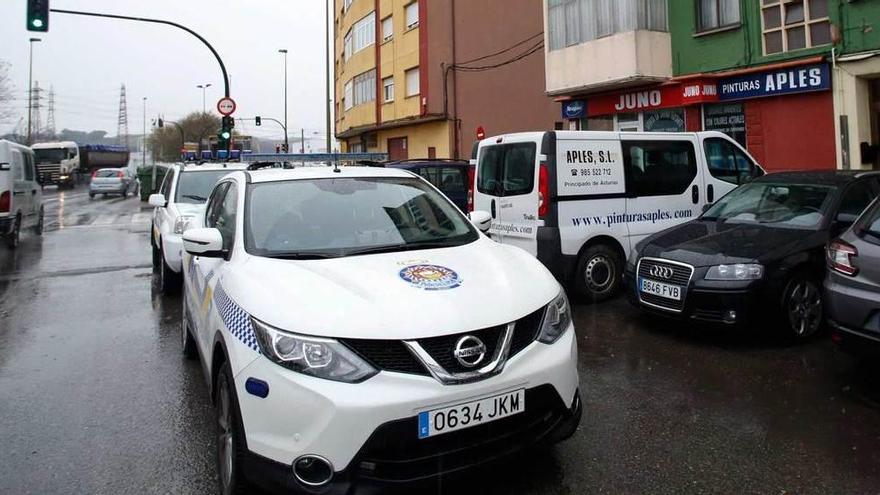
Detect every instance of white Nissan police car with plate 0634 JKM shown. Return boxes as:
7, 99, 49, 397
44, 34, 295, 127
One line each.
181, 167, 581, 493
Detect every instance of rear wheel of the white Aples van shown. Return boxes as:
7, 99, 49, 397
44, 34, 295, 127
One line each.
574, 244, 623, 302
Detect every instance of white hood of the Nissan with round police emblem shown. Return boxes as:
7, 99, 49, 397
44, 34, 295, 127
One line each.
221, 237, 560, 339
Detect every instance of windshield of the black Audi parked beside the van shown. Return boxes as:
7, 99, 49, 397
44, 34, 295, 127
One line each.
702, 182, 834, 229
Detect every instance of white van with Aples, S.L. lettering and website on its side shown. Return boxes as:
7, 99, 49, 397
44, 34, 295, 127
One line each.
473, 131, 764, 301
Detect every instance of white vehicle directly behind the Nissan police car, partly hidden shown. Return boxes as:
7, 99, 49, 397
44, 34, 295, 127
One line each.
149, 164, 246, 294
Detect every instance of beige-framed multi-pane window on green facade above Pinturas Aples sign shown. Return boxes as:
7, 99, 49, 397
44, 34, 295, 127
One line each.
761, 0, 831, 55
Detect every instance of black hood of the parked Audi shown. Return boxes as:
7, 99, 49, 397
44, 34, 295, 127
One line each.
639, 220, 822, 267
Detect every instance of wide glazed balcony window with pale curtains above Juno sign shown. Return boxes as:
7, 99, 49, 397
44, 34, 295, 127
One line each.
548, 0, 668, 50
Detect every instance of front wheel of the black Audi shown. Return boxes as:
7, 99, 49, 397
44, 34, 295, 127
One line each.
781, 274, 824, 341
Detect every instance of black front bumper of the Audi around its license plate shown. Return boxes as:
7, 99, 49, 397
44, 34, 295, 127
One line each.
624, 266, 778, 326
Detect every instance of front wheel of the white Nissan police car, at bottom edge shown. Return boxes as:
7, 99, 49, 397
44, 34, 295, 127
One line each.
214, 361, 250, 495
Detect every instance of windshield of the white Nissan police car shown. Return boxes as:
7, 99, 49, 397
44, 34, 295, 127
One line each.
245, 178, 479, 259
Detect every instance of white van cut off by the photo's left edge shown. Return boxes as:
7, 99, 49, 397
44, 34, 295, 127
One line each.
0, 140, 43, 249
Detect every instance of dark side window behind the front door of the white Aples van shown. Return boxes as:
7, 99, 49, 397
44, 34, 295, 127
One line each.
622, 141, 697, 196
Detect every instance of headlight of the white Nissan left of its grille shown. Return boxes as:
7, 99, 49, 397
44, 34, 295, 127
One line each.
251, 318, 379, 383
